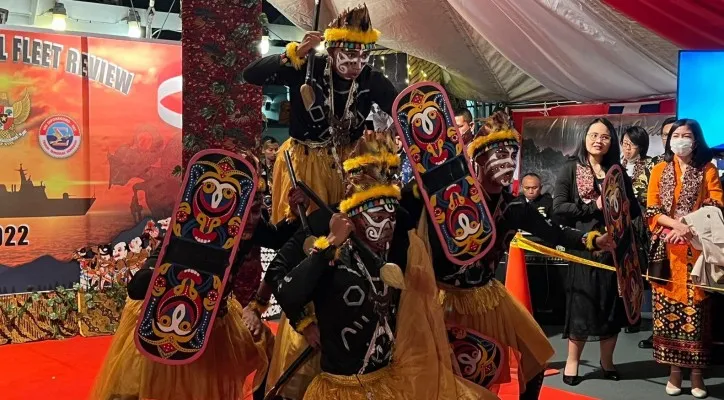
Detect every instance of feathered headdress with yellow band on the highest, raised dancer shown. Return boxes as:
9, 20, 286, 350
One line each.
324, 4, 380, 50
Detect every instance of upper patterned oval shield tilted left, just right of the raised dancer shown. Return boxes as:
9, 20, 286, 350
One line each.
392, 82, 495, 265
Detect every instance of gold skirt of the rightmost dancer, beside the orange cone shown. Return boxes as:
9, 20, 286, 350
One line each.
441, 279, 555, 393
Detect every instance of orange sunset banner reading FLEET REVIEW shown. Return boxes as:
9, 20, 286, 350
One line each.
0, 29, 181, 294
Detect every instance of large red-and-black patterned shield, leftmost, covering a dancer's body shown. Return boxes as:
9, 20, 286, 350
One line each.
135, 150, 257, 364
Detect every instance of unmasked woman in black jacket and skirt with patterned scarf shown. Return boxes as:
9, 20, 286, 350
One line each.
553, 118, 641, 386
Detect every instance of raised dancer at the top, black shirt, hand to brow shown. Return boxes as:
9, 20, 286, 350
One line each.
244, 6, 397, 223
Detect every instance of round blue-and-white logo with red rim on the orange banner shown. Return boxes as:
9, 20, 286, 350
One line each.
38, 115, 81, 158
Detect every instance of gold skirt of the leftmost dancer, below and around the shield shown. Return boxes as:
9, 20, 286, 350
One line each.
90, 299, 273, 400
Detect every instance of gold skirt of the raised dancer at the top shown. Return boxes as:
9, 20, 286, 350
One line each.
272, 138, 351, 224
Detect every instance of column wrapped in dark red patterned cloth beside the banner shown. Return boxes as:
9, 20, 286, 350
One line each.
181, 0, 262, 168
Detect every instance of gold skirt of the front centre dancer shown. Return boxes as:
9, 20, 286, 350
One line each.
304, 233, 497, 400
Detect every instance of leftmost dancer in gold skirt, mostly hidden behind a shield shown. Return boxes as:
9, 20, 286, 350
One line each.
90, 156, 306, 400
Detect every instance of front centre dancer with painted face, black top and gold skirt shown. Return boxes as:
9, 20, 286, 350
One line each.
274, 133, 495, 400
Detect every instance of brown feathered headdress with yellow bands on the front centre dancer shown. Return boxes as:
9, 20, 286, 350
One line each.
339, 132, 400, 216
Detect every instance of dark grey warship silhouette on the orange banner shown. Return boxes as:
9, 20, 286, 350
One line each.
0, 164, 96, 218
